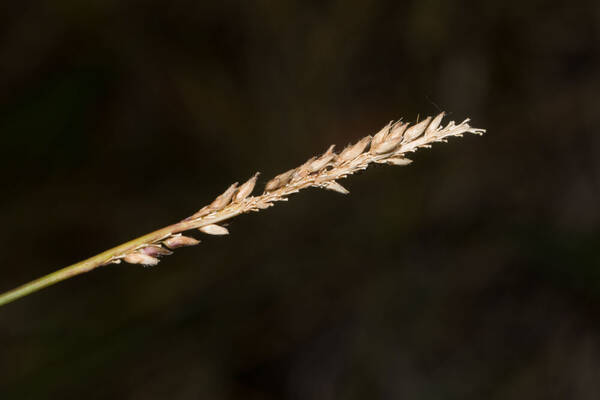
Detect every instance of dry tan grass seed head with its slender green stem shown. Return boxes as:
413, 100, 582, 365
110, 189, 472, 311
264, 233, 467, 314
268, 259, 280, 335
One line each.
0, 112, 485, 306
